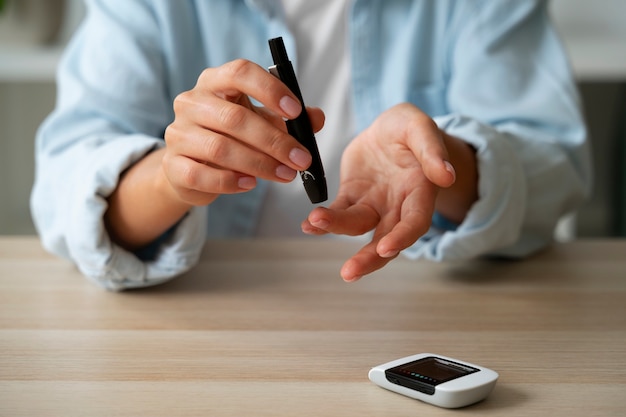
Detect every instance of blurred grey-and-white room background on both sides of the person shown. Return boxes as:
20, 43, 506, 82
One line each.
0, 0, 626, 238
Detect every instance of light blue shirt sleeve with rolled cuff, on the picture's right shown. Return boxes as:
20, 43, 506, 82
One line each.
406, 1, 591, 260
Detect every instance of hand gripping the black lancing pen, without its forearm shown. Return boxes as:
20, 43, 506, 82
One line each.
162, 59, 324, 206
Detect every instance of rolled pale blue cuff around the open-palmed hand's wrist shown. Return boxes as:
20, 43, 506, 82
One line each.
404, 115, 528, 261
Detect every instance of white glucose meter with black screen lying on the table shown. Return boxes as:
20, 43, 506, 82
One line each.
369, 353, 498, 408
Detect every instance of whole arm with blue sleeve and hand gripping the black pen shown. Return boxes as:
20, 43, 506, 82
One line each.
31, 0, 323, 289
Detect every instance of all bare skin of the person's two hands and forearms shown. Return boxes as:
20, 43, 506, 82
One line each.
105, 60, 478, 281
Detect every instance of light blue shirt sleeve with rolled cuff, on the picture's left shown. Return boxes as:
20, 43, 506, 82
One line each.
31, 0, 206, 290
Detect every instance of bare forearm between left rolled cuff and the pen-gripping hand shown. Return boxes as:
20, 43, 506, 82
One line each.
104, 148, 191, 250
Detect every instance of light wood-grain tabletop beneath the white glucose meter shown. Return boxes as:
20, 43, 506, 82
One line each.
0, 237, 626, 417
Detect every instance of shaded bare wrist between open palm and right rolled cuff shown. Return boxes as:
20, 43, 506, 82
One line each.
435, 132, 478, 223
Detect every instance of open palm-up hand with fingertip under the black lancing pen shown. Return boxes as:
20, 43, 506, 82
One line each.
302, 104, 477, 281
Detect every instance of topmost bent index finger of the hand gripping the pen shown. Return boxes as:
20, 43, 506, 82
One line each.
198, 59, 302, 119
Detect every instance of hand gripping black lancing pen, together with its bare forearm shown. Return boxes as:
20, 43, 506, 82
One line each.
105, 60, 324, 250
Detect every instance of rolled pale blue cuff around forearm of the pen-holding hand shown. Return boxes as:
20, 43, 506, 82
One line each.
66, 135, 207, 290
